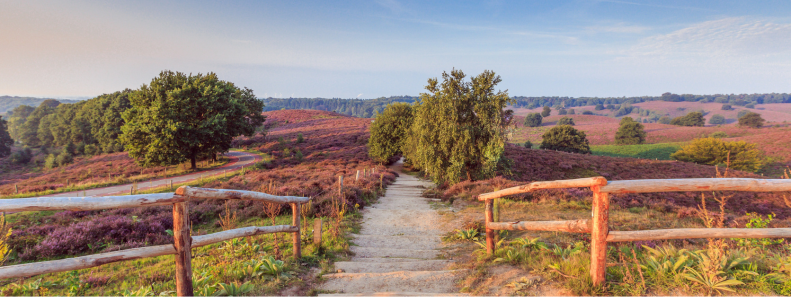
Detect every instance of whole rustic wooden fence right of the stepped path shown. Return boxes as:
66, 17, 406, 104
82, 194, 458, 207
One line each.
478, 177, 791, 285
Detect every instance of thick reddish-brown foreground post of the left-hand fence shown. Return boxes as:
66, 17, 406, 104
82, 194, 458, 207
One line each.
173, 202, 193, 296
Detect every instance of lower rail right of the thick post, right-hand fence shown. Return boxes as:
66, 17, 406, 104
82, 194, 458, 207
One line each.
607, 228, 791, 242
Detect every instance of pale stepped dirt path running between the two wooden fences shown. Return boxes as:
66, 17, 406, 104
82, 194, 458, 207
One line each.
319, 161, 459, 296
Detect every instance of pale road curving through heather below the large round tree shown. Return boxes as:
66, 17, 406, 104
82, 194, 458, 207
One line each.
46, 151, 262, 197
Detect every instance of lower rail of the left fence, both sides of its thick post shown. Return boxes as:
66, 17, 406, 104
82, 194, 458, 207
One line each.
0, 225, 297, 279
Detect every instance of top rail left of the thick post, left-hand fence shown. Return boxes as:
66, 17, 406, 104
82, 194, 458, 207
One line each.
0, 193, 186, 212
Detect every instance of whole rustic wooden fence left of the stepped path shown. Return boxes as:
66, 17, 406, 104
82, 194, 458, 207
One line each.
0, 186, 310, 296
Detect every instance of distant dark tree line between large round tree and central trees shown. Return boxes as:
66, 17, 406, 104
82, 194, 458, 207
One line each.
263, 96, 418, 118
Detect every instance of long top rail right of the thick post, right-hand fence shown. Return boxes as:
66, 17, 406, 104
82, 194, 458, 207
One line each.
601, 178, 791, 194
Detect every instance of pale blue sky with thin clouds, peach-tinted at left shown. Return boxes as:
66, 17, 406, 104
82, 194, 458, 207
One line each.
0, 0, 791, 98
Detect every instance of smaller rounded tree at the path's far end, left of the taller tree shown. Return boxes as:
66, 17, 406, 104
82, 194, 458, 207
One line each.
368, 102, 413, 163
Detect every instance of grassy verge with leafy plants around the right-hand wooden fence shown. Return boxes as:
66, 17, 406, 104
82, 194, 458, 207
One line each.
443, 199, 791, 295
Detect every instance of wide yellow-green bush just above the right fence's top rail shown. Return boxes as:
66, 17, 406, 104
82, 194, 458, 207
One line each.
670, 137, 766, 172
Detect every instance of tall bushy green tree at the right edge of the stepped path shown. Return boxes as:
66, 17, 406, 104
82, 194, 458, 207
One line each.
404, 69, 514, 184
